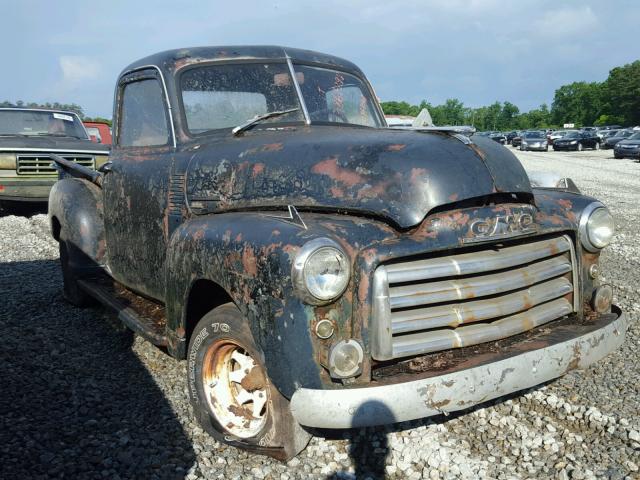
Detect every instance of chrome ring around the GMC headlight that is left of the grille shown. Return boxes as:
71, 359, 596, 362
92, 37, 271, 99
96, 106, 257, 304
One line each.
291, 237, 351, 305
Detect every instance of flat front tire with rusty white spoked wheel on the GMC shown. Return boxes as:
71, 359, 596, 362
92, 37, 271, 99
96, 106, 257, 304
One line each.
187, 303, 311, 460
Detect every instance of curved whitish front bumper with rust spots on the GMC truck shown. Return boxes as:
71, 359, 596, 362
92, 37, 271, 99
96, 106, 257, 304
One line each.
290, 307, 628, 428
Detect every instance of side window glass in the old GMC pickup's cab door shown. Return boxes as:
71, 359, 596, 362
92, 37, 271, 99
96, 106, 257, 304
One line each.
118, 78, 169, 147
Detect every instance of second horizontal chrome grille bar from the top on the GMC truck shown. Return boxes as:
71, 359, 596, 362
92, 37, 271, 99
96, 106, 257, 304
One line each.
389, 255, 571, 309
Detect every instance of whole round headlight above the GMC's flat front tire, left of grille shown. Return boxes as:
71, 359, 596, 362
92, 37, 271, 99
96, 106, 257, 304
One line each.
291, 238, 351, 305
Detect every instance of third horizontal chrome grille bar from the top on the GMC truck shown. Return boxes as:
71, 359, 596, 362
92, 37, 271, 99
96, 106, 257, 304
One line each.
391, 277, 573, 334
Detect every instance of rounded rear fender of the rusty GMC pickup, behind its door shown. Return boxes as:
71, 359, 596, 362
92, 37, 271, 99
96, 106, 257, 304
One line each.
49, 178, 106, 263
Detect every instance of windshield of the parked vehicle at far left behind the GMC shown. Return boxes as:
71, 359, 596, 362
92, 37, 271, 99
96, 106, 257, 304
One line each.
0, 110, 88, 140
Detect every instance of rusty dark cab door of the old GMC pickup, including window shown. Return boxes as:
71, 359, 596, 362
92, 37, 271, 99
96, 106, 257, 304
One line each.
103, 69, 175, 299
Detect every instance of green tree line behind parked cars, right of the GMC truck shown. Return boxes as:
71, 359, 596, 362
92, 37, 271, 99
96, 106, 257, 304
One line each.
381, 60, 640, 131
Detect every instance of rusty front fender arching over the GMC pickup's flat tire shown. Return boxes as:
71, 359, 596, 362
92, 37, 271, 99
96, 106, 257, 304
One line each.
166, 213, 340, 396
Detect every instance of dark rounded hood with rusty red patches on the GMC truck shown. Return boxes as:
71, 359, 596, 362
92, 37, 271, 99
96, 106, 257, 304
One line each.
186, 126, 532, 228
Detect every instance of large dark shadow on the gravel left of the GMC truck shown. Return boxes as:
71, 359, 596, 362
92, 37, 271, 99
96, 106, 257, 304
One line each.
0, 260, 195, 479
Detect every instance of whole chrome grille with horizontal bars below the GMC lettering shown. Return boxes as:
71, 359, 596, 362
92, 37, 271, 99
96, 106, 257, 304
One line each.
371, 236, 577, 360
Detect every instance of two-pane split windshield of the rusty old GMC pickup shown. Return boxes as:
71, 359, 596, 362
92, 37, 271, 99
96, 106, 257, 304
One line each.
181, 62, 381, 134
